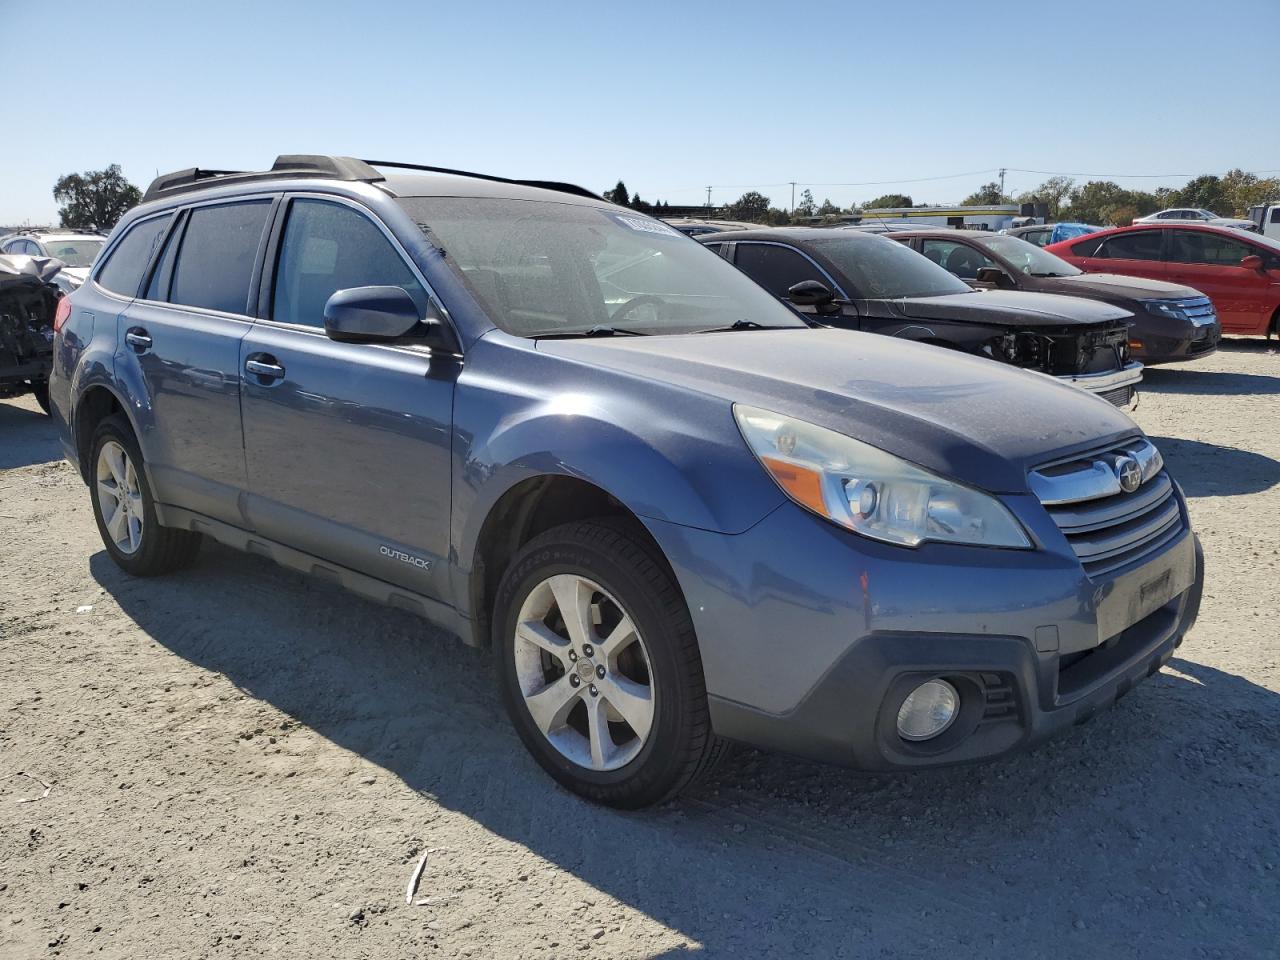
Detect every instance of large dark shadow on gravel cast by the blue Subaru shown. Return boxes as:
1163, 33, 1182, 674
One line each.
90, 545, 1280, 960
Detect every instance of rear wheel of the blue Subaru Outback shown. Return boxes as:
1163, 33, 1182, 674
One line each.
88, 416, 201, 577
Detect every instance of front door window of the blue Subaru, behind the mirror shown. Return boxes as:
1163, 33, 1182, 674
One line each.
271, 200, 426, 326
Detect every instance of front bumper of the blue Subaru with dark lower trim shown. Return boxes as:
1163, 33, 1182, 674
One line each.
654, 504, 1203, 771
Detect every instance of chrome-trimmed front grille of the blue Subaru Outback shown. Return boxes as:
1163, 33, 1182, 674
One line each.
1029, 440, 1183, 577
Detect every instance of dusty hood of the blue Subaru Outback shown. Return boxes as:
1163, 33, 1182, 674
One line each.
538, 330, 1140, 493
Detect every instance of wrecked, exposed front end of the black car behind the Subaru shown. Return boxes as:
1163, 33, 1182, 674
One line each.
983, 323, 1142, 410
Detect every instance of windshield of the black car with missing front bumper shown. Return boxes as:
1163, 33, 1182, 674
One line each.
808, 233, 973, 300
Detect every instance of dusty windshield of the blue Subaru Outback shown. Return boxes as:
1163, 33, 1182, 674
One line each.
399, 197, 805, 337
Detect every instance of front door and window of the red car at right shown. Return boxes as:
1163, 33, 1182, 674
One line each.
1169, 229, 1272, 333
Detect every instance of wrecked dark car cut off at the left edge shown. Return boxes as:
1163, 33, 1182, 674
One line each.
0, 255, 63, 413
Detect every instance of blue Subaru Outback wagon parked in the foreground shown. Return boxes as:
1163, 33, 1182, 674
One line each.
50, 156, 1203, 806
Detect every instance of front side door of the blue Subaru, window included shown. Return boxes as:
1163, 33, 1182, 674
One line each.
239, 197, 461, 599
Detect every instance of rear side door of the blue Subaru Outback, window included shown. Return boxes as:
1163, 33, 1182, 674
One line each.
116, 196, 276, 526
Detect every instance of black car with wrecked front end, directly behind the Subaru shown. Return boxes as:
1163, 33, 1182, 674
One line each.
699, 228, 1142, 407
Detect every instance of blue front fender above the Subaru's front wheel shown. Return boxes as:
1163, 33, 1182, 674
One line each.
452, 340, 783, 571
